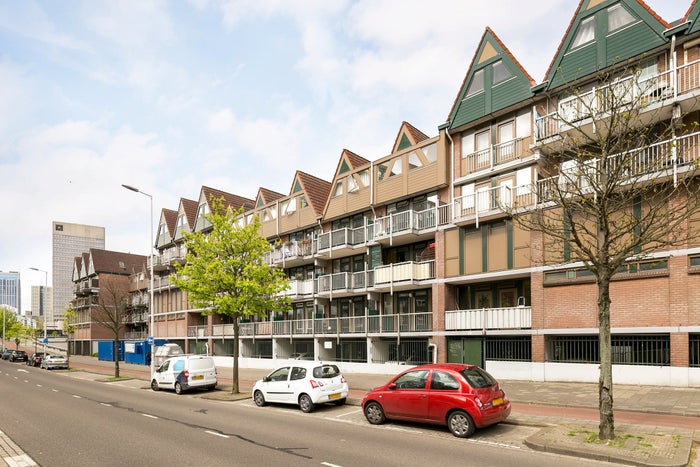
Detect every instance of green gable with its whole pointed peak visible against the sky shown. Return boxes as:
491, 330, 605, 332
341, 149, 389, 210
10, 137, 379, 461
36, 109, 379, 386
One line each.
448, 27, 535, 129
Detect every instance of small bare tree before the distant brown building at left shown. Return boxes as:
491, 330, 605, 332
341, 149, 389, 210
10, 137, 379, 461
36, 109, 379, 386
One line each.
92, 274, 131, 378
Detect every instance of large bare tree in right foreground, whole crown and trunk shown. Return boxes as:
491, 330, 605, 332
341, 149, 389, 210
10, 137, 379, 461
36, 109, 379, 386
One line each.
501, 68, 700, 439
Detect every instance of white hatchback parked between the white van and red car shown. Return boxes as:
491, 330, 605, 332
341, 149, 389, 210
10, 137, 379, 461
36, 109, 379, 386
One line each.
253, 360, 348, 413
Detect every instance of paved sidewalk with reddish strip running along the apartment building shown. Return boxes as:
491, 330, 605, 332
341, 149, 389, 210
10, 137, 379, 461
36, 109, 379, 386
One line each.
9, 356, 700, 467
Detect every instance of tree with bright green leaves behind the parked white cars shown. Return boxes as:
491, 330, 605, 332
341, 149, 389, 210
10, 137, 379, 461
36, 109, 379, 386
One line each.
171, 200, 289, 394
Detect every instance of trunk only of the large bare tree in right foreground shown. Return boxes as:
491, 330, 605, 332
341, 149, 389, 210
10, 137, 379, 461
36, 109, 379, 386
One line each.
598, 277, 615, 439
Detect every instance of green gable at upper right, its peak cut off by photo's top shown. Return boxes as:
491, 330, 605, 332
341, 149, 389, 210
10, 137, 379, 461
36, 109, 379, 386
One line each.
545, 0, 671, 90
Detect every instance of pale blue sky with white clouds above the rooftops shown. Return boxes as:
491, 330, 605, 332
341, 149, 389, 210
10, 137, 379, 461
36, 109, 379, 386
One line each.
0, 0, 691, 311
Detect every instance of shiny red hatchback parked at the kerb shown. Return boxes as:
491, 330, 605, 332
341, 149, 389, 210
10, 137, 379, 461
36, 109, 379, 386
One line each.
362, 363, 510, 438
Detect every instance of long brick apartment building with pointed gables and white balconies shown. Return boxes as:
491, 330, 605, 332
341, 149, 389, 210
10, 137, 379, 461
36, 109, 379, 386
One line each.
137, 0, 700, 386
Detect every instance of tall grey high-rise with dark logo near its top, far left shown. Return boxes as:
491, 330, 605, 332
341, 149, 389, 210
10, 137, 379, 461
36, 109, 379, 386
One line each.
52, 221, 105, 328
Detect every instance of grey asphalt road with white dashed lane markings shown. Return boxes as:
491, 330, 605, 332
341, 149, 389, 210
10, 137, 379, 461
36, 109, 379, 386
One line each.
0, 361, 624, 467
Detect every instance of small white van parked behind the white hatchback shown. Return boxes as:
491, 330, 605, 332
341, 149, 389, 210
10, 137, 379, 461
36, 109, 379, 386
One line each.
151, 355, 217, 394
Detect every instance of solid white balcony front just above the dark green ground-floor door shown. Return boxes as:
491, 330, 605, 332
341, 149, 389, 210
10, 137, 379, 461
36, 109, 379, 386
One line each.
445, 306, 532, 331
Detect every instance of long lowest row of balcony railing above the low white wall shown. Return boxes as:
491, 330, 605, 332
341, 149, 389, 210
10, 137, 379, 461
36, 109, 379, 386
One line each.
204, 312, 433, 338
